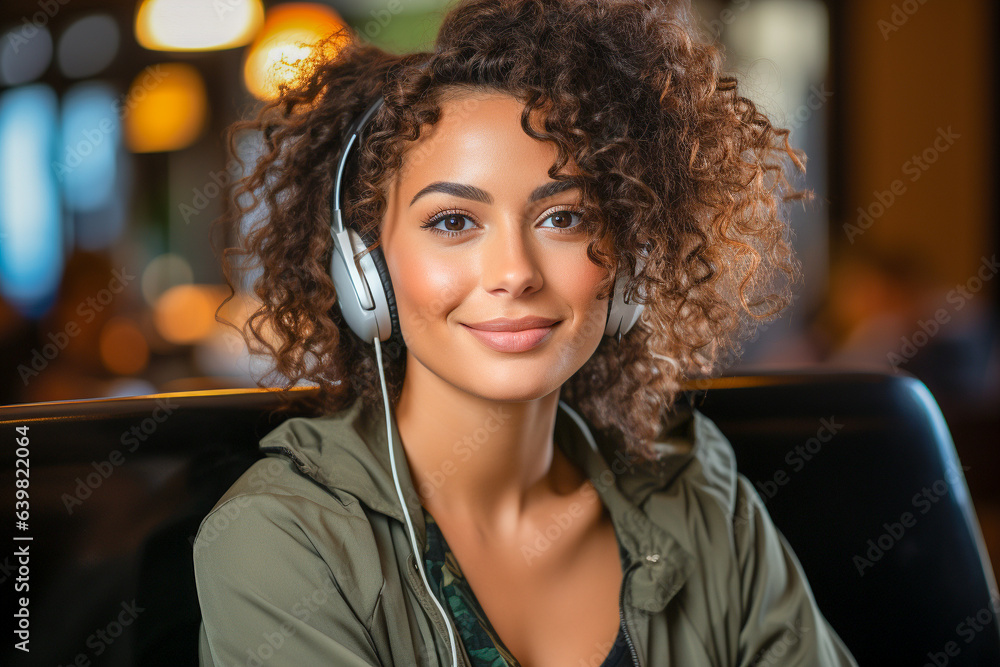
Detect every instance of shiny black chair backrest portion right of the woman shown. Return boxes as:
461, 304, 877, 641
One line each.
696, 373, 1000, 667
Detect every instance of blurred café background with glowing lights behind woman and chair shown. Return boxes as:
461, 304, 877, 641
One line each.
0, 0, 1000, 571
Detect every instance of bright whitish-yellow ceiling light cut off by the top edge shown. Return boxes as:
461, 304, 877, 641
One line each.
135, 0, 264, 51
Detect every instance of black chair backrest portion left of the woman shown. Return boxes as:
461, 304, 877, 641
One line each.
0, 390, 304, 666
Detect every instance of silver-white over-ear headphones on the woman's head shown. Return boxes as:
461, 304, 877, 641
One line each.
330, 97, 645, 350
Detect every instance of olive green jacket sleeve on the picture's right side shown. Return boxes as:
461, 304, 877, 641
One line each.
733, 474, 857, 667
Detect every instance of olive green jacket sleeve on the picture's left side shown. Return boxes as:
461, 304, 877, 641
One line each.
194, 493, 381, 667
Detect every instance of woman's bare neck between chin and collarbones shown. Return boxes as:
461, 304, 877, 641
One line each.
394, 356, 587, 542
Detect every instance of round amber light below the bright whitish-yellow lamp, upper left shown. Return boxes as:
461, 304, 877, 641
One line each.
125, 63, 208, 153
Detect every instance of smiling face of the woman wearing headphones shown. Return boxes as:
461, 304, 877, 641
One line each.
382, 93, 608, 401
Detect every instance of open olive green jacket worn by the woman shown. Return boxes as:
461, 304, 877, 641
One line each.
194, 400, 857, 667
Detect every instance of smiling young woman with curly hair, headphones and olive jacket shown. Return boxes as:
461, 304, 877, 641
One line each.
194, 0, 855, 667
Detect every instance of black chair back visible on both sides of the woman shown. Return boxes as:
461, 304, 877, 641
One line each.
0, 373, 1000, 667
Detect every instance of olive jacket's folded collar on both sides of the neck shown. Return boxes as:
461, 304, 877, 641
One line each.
254, 397, 699, 611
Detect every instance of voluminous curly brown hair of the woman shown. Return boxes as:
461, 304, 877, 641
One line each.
219, 0, 812, 460
